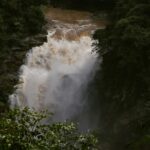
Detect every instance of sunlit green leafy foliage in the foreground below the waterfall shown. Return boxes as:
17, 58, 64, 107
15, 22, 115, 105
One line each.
0, 108, 98, 150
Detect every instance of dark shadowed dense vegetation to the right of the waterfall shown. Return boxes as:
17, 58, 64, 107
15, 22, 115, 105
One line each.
91, 0, 150, 150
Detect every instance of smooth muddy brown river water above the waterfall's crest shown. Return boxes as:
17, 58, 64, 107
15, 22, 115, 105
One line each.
45, 7, 107, 28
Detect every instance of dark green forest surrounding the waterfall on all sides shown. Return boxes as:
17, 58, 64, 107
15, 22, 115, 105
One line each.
0, 0, 150, 150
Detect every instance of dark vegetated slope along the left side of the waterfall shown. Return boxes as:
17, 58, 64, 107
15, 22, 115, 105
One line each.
0, 0, 46, 108
